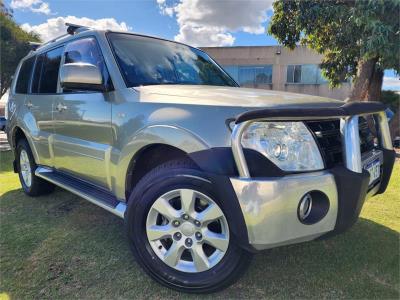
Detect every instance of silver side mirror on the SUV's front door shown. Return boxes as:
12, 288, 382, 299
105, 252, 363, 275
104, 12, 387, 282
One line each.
60, 63, 106, 92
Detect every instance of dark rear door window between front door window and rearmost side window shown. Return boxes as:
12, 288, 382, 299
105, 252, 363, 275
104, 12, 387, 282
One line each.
32, 47, 63, 94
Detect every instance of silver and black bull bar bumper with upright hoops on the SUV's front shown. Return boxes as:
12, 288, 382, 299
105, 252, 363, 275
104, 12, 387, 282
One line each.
230, 104, 395, 250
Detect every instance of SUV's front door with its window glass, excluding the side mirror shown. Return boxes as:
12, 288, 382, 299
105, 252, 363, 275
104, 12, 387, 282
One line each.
53, 37, 113, 189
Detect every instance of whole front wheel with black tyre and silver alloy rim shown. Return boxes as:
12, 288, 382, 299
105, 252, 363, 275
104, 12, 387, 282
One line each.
125, 160, 252, 293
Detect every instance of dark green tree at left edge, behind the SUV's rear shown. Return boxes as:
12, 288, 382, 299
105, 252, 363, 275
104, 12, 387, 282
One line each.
0, 1, 40, 97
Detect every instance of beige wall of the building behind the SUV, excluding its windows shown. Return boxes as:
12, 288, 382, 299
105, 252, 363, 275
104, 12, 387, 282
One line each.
202, 46, 351, 100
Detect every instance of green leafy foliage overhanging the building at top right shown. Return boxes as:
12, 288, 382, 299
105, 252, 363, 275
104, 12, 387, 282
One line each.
268, 0, 400, 86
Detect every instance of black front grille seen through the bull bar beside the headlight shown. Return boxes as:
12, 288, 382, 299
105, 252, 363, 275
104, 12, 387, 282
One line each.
306, 117, 374, 168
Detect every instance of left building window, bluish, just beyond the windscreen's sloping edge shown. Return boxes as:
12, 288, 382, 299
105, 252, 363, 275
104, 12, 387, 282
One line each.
224, 65, 272, 86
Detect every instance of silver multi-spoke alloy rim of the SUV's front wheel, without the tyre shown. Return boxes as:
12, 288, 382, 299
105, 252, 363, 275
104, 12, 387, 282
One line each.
146, 189, 229, 273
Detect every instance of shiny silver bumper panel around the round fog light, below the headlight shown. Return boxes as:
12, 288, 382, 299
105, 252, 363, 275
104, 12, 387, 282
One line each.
231, 172, 338, 250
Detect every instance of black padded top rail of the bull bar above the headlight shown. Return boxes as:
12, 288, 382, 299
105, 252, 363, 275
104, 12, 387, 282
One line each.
235, 102, 386, 124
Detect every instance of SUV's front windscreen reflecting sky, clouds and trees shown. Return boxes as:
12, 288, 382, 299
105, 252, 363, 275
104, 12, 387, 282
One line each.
108, 33, 237, 87
